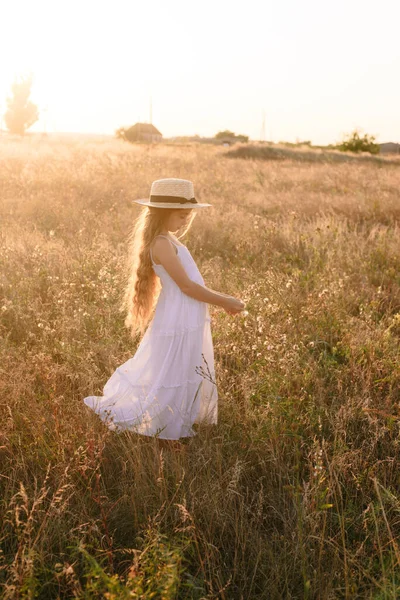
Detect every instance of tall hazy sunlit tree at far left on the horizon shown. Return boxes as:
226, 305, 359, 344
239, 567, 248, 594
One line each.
4, 75, 39, 135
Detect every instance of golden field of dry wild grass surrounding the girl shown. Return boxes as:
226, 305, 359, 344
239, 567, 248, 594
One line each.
0, 138, 400, 600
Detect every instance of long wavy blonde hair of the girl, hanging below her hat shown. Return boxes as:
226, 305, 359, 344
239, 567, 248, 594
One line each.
120, 206, 195, 338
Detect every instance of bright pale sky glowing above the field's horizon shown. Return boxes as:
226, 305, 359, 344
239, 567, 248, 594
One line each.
0, 0, 400, 145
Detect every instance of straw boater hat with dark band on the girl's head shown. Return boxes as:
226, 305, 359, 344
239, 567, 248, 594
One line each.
133, 177, 212, 208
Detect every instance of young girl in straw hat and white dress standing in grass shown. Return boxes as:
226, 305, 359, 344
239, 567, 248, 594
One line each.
84, 178, 245, 440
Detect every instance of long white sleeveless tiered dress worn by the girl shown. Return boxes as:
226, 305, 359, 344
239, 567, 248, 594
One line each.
84, 236, 218, 440
